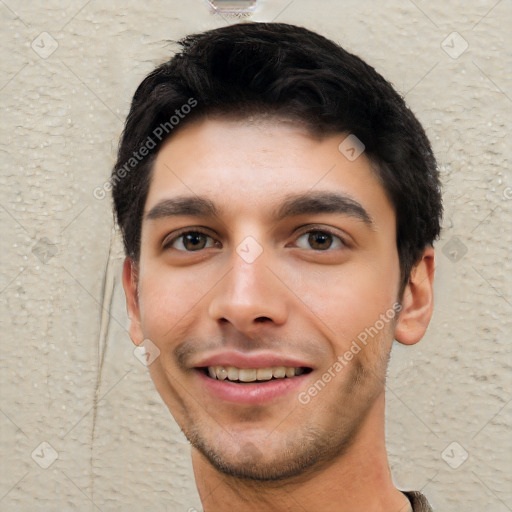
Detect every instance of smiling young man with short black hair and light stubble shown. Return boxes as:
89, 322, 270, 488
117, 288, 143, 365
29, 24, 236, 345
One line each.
112, 23, 442, 512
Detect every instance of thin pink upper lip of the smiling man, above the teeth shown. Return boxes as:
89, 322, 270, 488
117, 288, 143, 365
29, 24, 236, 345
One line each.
194, 351, 313, 368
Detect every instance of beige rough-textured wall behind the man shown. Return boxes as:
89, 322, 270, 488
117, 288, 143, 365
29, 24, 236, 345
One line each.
0, 0, 512, 512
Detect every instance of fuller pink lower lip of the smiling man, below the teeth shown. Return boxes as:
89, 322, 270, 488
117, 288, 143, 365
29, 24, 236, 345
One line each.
197, 370, 309, 405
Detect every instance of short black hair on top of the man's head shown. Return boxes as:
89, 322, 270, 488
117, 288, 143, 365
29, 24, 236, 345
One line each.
111, 23, 442, 290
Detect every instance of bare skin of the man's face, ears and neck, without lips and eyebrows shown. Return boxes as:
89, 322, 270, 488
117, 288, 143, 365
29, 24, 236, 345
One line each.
123, 118, 434, 512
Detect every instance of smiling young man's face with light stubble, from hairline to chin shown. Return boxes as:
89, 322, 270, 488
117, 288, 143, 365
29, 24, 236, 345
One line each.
125, 119, 400, 480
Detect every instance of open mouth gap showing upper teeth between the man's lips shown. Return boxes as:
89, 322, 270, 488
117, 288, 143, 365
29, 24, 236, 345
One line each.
199, 366, 312, 384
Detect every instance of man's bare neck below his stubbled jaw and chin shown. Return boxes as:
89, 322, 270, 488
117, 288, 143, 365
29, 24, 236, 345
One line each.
192, 395, 412, 512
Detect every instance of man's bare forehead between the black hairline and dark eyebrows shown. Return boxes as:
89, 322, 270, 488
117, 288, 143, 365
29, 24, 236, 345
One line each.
145, 118, 394, 226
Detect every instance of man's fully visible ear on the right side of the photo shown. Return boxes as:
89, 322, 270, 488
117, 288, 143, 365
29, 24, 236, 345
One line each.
395, 246, 435, 345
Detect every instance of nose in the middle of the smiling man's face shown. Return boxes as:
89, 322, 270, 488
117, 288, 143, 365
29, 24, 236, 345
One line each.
209, 247, 291, 337
